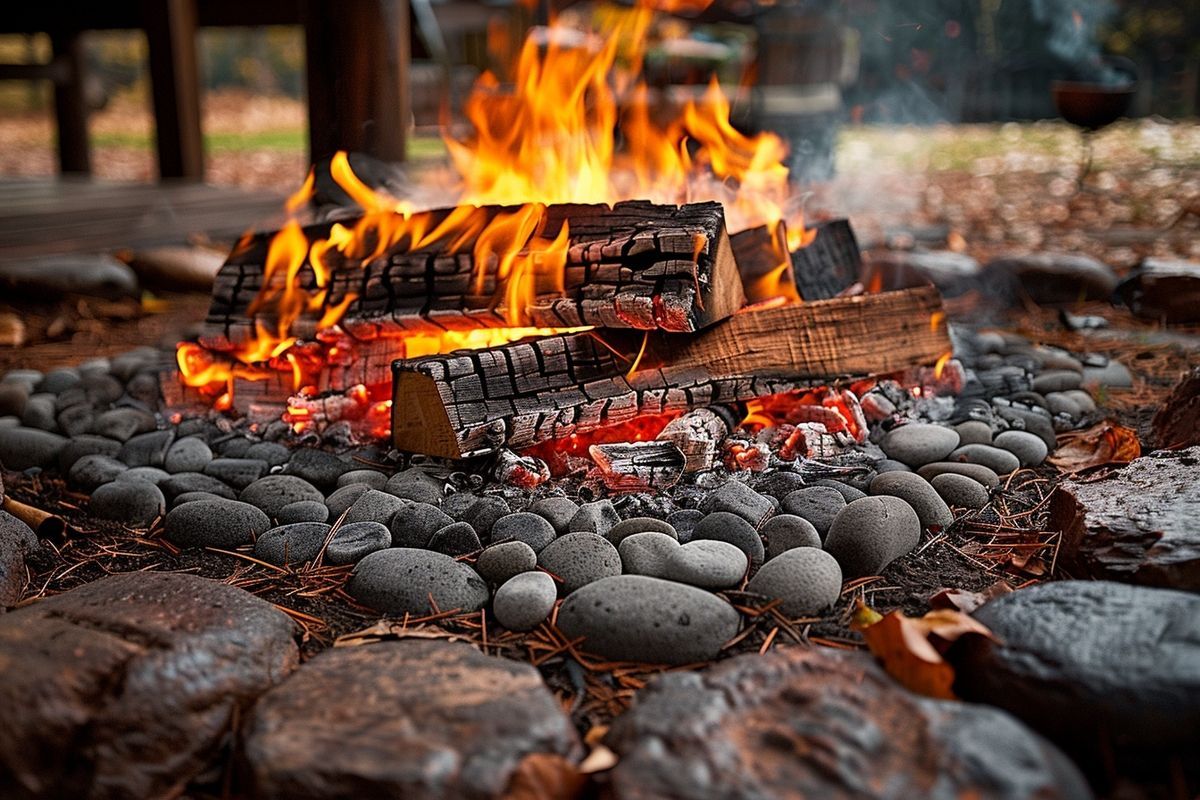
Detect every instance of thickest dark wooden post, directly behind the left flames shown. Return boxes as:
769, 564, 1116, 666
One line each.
305, 0, 410, 163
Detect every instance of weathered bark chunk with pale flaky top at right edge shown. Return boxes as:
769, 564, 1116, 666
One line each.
1050, 446, 1200, 591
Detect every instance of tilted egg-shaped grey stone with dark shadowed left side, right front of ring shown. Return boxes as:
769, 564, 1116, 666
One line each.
824, 495, 920, 579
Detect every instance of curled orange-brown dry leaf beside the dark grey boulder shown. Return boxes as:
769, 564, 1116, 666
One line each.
862, 609, 996, 700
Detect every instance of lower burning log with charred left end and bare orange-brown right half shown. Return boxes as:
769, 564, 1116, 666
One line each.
392, 287, 950, 458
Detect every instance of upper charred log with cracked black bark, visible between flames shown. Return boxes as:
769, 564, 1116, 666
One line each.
203, 201, 745, 349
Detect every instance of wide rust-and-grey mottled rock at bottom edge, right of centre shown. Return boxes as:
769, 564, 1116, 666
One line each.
609, 647, 1091, 800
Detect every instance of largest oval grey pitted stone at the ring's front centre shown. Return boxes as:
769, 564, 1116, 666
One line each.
558, 578, 749, 664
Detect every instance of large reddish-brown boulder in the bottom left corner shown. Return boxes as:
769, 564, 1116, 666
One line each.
0, 572, 299, 798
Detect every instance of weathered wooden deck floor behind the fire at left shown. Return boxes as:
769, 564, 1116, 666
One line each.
0, 178, 283, 261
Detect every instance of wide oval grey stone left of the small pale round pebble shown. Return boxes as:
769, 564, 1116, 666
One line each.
346, 547, 488, 616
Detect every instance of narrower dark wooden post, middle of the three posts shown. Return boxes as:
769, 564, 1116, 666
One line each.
142, 0, 204, 180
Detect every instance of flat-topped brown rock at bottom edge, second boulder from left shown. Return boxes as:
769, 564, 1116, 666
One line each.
244, 638, 582, 800
